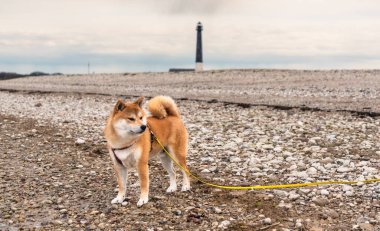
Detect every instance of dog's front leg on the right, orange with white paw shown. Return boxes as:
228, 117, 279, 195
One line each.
137, 155, 149, 207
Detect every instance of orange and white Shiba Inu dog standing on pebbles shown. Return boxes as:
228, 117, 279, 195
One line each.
104, 96, 190, 207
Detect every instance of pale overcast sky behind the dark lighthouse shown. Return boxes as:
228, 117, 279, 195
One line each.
0, 0, 380, 73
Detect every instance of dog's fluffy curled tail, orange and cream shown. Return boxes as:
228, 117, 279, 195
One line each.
148, 95, 180, 119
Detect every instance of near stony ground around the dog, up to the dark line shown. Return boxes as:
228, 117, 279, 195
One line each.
0, 91, 380, 231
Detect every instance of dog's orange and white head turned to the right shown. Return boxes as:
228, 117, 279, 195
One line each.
112, 96, 147, 136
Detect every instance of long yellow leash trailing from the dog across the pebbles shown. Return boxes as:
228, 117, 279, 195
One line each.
154, 136, 380, 190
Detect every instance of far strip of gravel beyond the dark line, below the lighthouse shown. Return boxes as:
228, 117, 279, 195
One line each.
0, 69, 380, 113
